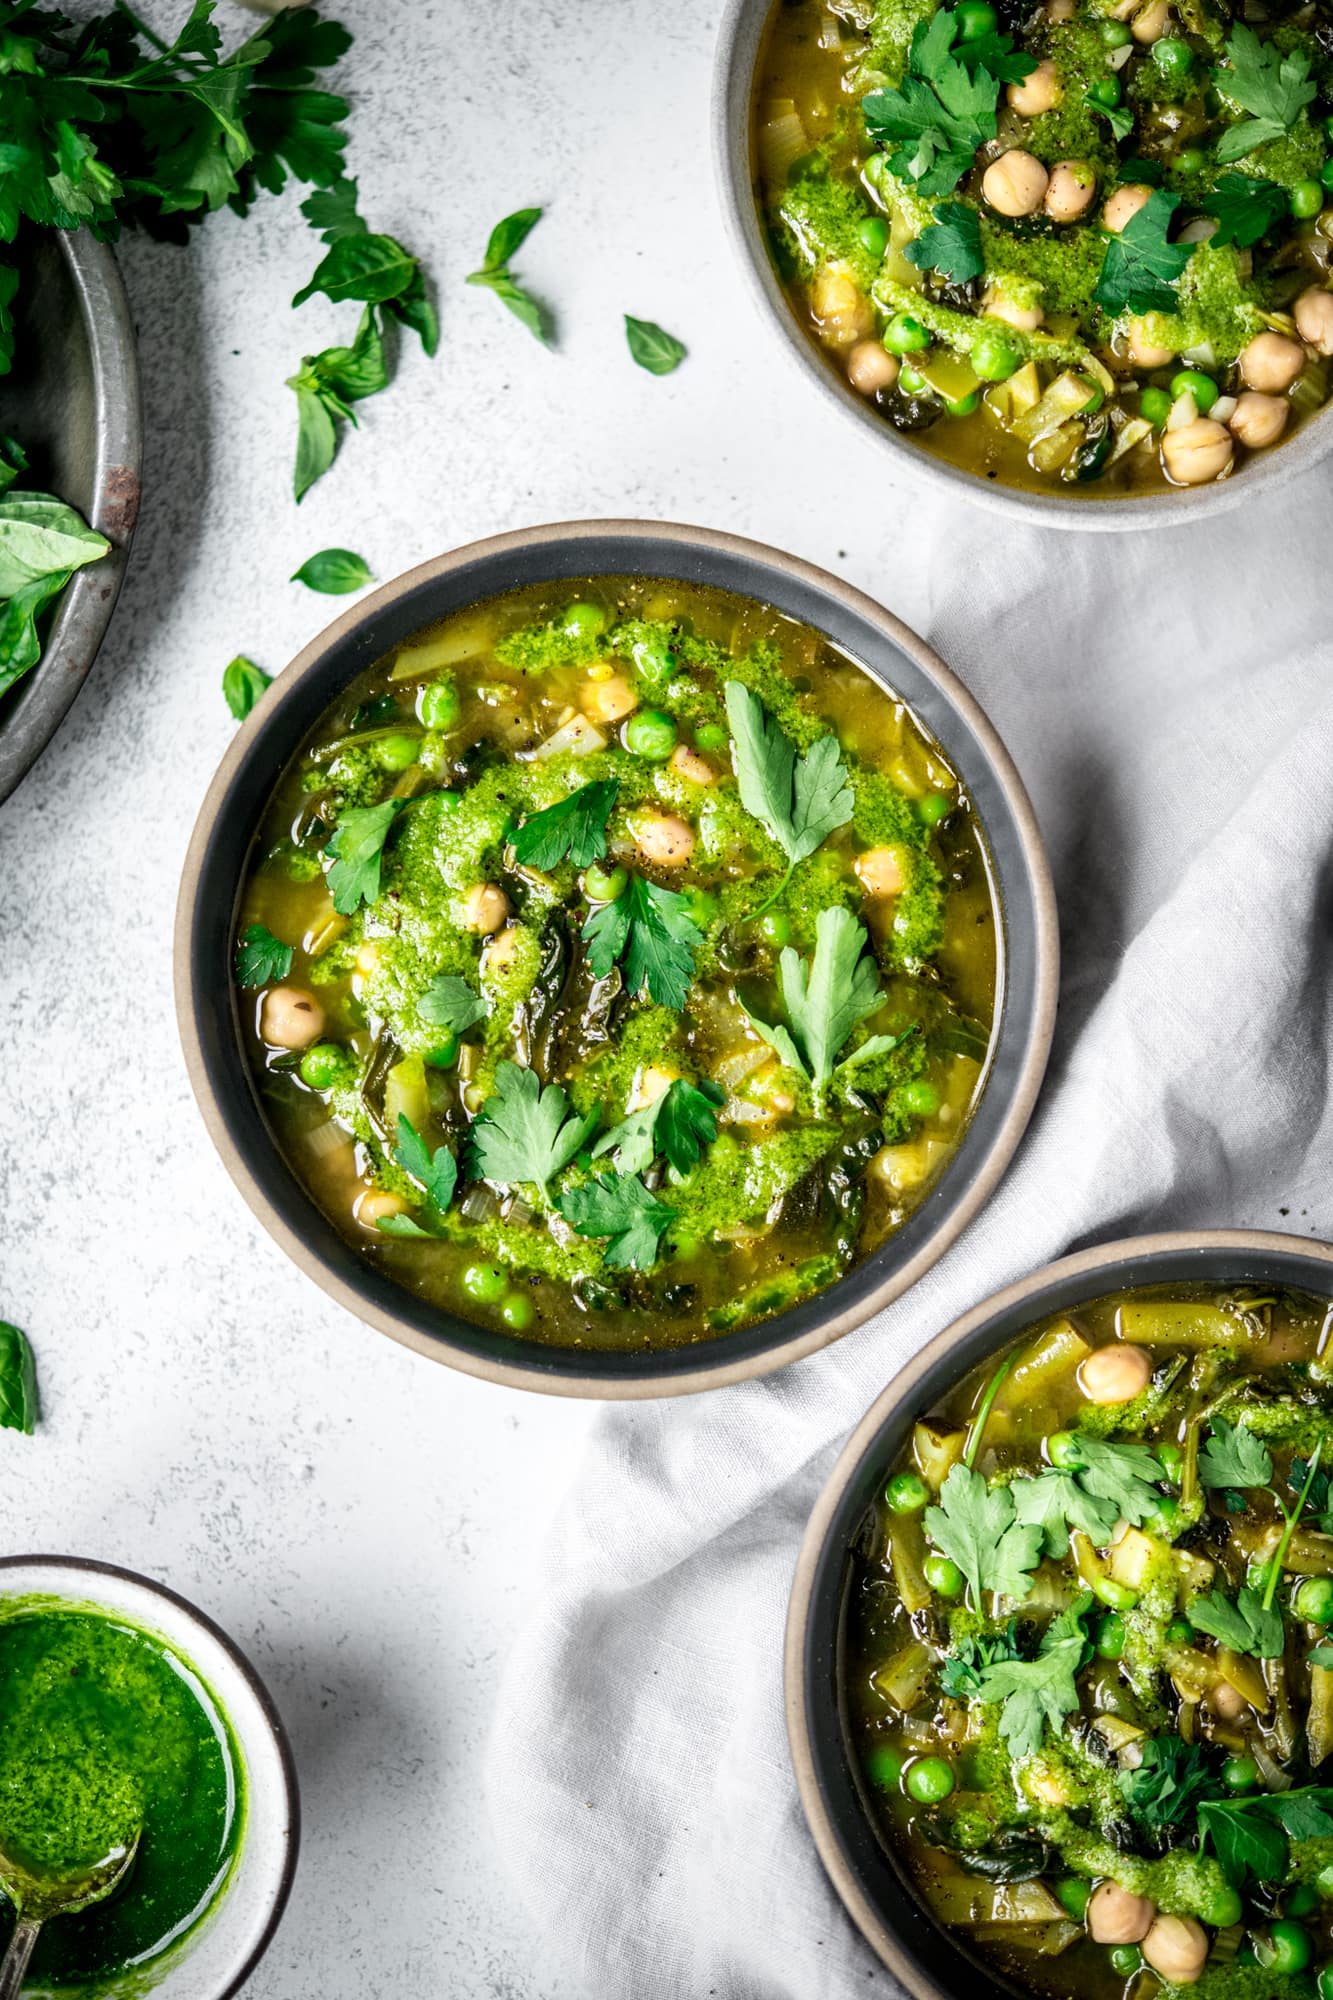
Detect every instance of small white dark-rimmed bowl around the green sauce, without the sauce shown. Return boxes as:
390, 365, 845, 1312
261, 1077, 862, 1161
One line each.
0, 1556, 300, 2000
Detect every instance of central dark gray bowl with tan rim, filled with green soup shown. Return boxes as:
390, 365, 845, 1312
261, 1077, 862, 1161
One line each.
178, 522, 1055, 1396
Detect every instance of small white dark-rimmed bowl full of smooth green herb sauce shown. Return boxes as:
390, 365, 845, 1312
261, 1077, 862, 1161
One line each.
0, 1556, 298, 2000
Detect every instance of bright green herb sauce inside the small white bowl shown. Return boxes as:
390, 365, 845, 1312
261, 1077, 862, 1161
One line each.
0, 1604, 244, 1992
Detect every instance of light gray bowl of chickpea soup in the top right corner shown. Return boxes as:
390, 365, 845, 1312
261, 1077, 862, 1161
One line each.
719, 0, 1333, 528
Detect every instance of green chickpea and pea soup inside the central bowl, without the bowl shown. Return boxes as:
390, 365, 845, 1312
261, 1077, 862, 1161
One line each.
236, 578, 997, 1348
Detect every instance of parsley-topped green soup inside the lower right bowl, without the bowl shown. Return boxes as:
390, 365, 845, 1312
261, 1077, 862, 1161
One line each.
845, 1286, 1333, 2000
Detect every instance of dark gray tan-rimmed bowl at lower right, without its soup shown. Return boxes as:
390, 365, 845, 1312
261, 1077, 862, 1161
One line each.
785, 1230, 1333, 2000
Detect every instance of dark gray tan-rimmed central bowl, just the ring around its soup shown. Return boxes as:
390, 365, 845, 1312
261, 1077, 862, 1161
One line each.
176, 520, 1059, 1398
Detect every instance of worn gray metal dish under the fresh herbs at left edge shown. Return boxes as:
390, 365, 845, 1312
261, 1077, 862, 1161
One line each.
0, 230, 142, 800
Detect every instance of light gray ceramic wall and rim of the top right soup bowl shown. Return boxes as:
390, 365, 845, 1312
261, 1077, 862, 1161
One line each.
713, 0, 1333, 532
